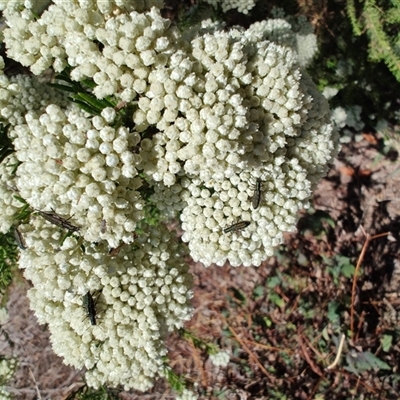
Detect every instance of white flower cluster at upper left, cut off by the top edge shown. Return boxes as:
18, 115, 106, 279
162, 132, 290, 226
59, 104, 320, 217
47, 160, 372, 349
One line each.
0, 0, 174, 101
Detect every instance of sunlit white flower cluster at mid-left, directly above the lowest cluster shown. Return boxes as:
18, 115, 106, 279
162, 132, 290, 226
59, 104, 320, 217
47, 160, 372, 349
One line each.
12, 104, 143, 247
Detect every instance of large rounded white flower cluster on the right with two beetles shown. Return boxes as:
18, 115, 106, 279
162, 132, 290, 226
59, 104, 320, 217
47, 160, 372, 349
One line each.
138, 28, 338, 266
